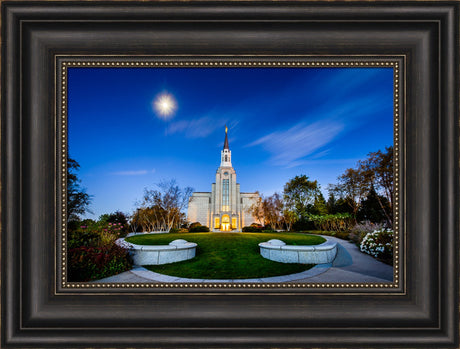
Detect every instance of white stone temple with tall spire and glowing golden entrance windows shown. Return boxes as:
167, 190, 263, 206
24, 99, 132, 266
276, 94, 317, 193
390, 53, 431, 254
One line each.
187, 127, 259, 231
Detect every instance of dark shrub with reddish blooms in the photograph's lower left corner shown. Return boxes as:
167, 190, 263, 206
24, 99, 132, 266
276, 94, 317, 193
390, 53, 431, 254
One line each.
68, 244, 132, 281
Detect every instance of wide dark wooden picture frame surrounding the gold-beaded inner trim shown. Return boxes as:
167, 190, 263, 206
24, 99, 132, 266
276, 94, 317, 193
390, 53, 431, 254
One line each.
1, 1, 460, 348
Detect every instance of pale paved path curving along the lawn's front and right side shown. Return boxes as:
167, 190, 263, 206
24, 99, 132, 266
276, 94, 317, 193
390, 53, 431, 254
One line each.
94, 236, 393, 283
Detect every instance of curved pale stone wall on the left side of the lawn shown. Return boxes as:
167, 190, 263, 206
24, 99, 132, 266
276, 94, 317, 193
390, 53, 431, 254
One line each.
116, 239, 197, 265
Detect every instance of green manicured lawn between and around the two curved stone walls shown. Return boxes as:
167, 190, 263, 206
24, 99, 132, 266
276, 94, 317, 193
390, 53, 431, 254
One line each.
126, 233, 325, 279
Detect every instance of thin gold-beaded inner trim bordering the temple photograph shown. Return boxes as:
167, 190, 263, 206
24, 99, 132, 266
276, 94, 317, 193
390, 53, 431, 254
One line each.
55, 55, 406, 295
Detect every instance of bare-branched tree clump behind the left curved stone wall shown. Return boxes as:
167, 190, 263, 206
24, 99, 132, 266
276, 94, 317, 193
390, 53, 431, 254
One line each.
138, 179, 193, 231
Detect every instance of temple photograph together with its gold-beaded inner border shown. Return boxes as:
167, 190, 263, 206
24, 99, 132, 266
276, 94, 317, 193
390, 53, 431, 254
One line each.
63, 56, 396, 289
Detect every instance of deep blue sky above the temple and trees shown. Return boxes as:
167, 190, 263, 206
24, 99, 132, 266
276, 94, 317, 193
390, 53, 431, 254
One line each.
68, 68, 393, 218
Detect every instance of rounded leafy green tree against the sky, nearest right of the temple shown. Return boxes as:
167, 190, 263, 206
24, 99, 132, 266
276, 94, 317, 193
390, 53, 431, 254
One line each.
283, 175, 321, 219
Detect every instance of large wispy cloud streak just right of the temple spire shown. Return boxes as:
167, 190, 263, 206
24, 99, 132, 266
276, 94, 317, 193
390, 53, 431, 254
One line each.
249, 121, 344, 167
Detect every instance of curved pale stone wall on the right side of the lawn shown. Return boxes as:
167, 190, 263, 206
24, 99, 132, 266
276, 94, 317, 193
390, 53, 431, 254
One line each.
259, 239, 337, 264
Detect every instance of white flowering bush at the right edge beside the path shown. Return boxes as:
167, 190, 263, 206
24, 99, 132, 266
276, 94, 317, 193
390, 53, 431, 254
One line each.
359, 228, 393, 261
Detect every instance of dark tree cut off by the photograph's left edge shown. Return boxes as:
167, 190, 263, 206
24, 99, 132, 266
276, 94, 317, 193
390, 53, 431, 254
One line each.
67, 156, 91, 222
